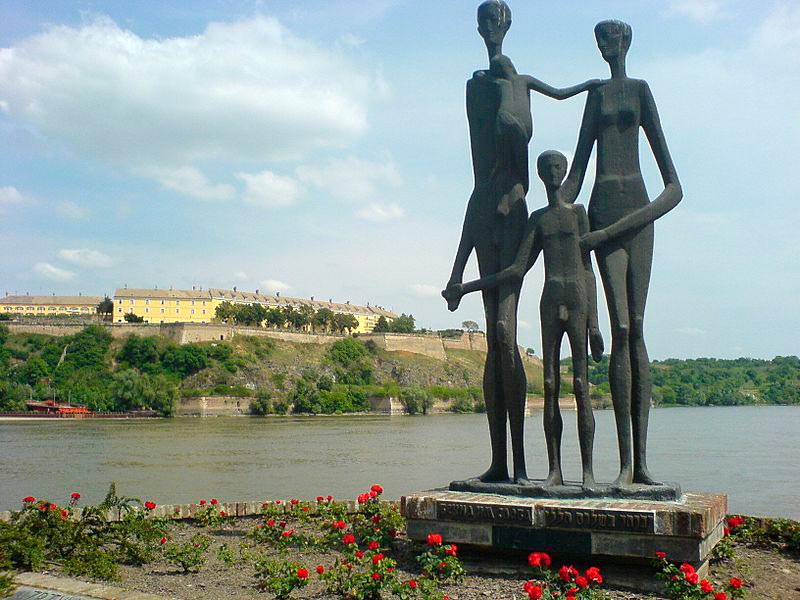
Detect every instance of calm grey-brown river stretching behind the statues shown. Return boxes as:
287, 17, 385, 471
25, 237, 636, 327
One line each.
0, 407, 800, 519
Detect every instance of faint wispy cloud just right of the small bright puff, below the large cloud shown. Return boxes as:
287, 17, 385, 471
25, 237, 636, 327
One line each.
297, 157, 403, 202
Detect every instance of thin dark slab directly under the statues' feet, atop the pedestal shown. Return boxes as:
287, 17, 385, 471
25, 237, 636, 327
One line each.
450, 477, 683, 502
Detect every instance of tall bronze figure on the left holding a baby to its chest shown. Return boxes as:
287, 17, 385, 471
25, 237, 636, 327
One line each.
447, 0, 592, 483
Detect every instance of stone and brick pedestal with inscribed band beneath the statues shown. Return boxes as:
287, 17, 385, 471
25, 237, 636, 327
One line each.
401, 490, 728, 591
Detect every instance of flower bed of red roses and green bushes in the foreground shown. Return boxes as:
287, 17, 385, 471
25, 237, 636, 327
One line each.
0, 485, 800, 600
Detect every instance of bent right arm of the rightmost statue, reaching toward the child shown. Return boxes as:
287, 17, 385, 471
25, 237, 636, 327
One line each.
587, 82, 683, 248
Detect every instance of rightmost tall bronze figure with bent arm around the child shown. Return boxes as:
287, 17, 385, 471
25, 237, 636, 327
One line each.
562, 21, 683, 487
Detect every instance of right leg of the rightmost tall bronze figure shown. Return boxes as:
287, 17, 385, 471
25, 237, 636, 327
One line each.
628, 225, 658, 485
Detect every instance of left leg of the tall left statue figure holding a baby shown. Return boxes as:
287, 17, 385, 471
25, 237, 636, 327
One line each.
478, 289, 508, 481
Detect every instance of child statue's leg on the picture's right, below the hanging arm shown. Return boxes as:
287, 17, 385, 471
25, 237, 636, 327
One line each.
567, 314, 595, 489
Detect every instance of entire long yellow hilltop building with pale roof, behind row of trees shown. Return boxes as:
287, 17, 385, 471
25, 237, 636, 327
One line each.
114, 288, 397, 333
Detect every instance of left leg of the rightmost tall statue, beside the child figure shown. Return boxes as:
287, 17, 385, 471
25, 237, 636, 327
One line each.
597, 243, 633, 486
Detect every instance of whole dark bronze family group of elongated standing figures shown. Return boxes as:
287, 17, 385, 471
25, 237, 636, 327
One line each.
442, 0, 682, 491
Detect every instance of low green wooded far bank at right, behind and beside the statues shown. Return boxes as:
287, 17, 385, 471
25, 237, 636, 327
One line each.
580, 356, 800, 406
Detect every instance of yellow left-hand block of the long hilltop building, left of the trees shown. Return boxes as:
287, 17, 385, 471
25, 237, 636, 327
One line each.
114, 288, 214, 323
